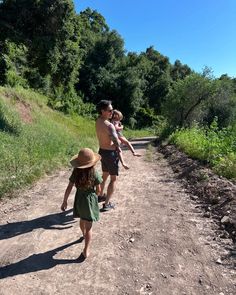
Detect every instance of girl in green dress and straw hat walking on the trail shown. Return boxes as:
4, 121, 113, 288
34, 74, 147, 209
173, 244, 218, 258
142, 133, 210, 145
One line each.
61, 148, 102, 259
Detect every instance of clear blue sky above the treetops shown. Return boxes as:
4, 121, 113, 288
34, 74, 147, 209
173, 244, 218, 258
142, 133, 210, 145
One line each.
74, 0, 236, 77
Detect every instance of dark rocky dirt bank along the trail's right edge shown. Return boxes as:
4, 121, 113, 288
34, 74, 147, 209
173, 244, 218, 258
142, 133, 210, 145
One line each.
158, 145, 236, 242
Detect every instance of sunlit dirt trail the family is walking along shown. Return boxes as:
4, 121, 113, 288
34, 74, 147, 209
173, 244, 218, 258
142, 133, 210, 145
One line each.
0, 141, 236, 295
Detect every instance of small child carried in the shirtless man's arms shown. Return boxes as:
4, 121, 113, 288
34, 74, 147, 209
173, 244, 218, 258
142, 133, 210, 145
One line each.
111, 110, 141, 157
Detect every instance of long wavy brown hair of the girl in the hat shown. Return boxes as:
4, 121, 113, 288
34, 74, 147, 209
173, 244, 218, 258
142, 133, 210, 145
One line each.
74, 166, 95, 188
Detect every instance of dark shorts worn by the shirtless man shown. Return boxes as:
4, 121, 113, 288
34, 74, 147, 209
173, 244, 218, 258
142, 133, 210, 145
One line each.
98, 149, 119, 175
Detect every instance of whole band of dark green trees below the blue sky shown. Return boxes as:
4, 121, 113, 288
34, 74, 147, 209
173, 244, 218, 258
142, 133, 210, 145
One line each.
0, 0, 236, 135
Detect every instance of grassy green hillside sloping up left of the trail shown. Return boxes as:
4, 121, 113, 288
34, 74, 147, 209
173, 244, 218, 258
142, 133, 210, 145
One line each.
0, 87, 153, 198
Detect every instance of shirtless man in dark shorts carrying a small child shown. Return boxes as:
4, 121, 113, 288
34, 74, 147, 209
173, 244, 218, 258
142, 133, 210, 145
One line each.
96, 100, 120, 211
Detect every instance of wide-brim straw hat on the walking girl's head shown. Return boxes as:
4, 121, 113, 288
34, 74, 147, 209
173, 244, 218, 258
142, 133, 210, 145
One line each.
70, 148, 101, 169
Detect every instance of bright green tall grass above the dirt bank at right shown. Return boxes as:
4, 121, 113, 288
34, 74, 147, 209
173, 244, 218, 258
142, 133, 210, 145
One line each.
170, 121, 236, 179
